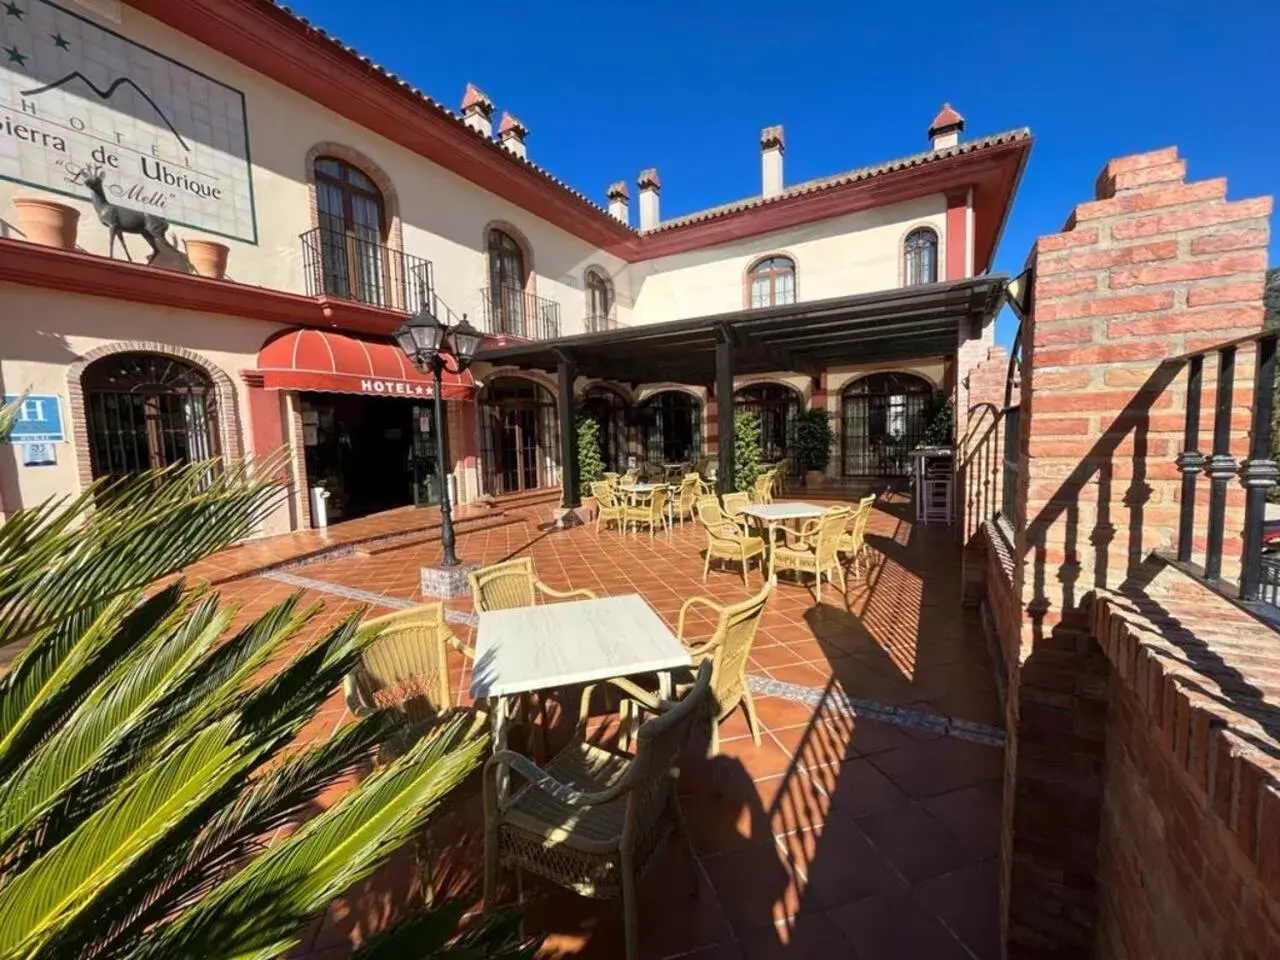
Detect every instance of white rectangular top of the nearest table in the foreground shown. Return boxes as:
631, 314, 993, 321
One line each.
471, 594, 691, 699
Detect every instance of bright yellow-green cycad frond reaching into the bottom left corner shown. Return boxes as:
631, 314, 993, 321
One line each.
0, 721, 250, 957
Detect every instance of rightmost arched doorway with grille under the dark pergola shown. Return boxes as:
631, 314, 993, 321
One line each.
840, 372, 933, 476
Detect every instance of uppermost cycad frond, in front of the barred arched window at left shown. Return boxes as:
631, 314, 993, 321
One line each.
0, 458, 283, 645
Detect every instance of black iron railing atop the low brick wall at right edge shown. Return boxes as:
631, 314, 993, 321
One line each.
1166, 330, 1280, 604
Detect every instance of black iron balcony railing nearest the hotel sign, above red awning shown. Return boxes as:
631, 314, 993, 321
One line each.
301, 227, 435, 314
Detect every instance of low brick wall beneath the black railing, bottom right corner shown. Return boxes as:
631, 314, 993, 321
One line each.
1091, 578, 1280, 960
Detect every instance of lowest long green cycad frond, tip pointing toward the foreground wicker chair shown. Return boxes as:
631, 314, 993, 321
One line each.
142, 721, 485, 960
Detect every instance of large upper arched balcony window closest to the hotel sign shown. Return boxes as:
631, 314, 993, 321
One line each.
311, 156, 396, 307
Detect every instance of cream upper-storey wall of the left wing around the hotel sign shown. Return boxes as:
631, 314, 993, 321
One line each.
0, 5, 631, 333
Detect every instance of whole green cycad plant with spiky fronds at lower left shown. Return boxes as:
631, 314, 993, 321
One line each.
0, 412, 532, 960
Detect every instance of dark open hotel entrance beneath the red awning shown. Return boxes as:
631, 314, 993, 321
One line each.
300, 393, 443, 520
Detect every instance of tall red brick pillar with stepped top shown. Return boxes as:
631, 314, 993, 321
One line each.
1001, 148, 1271, 957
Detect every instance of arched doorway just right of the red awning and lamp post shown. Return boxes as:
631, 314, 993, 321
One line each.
480, 376, 559, 494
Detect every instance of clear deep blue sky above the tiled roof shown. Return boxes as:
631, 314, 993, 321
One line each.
291, 0, 1280, 340
